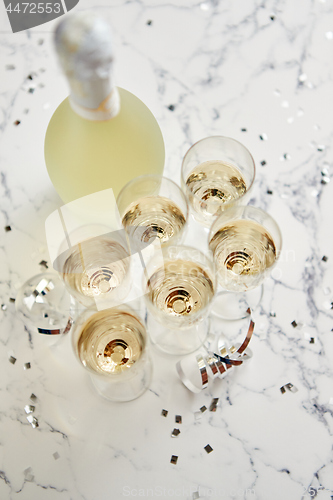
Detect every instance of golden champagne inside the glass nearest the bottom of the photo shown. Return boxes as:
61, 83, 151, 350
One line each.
77, 308, 146, 374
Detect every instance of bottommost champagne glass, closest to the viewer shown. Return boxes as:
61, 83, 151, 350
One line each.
72, 305, 152, 402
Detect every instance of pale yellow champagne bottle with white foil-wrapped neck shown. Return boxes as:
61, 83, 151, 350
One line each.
44, 12, 165, 203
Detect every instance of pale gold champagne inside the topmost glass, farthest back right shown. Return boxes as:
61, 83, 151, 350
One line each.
186, 160, 247, 216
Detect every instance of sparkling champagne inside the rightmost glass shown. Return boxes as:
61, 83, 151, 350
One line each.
209, 220, 277, 291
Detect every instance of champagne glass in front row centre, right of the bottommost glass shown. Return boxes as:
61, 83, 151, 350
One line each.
144, 245, 216, 355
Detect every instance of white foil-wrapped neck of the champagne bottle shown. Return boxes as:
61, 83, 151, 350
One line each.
55, 12, 120, 120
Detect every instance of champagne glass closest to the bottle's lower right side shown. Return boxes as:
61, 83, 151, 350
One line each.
117, 175, 189, 251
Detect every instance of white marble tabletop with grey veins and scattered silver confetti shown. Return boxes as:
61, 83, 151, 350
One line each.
0, 0, 333, 500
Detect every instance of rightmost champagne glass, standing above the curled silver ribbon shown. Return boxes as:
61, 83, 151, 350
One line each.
208, 206, 282, 319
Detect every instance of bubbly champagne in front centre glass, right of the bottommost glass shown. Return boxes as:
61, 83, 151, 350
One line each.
147, 260, 214, 326
